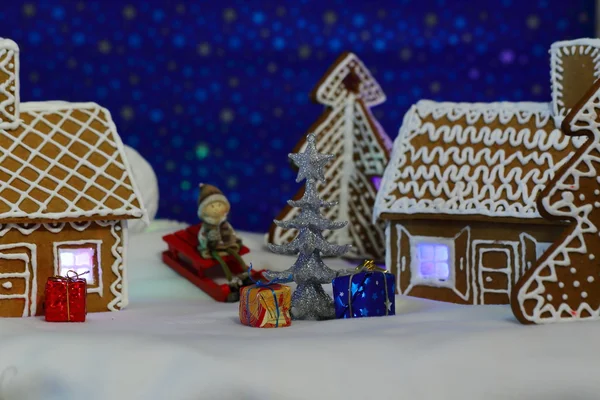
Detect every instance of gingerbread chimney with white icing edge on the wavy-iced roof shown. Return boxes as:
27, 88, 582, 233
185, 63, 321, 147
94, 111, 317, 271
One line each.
550, 39, 600, 117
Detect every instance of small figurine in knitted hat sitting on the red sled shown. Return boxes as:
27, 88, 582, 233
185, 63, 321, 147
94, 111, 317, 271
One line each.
198, 183, 252, 293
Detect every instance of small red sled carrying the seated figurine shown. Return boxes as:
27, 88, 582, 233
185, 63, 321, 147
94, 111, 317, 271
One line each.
162, 224, 263, 302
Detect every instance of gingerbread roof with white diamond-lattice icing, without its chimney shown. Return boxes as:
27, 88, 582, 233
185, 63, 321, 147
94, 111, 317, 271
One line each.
0, 102, 145, 222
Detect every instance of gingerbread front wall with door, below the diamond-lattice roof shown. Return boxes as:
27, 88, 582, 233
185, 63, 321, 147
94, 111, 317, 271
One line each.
0, 221, 124, 317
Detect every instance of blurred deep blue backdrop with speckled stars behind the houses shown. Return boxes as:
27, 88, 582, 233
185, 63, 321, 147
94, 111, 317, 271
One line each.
0, 0, 595, 231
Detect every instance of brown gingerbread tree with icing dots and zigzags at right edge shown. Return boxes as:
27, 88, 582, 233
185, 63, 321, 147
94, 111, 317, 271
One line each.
511, 81, 600, 324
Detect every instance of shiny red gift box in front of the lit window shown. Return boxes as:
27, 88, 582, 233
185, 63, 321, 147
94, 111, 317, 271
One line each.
45, 274, 87, 322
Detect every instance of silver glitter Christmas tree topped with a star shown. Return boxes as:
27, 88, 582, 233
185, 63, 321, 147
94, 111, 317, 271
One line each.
265, 134, 350, 320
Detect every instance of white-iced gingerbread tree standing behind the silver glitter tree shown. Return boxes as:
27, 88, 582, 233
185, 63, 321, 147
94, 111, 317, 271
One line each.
267, 53, 391, 260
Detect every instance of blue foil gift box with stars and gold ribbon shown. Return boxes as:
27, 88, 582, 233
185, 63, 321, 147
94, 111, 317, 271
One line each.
333, 271, 396, 319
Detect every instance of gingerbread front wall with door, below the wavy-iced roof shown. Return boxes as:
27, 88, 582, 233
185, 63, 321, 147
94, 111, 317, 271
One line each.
386, 220, 563, 304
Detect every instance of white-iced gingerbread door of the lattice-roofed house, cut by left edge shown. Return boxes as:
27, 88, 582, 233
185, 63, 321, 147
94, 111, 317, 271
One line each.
0, 243, 37, 317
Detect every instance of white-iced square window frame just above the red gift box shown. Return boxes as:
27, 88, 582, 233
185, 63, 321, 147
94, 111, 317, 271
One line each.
54, 240, 103, 296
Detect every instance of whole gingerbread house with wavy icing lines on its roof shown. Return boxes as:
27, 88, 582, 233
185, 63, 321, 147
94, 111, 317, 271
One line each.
374, 39, 600, 304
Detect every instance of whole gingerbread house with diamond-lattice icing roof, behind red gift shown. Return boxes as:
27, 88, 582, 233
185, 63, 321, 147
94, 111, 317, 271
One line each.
0, 39, 145, 317
